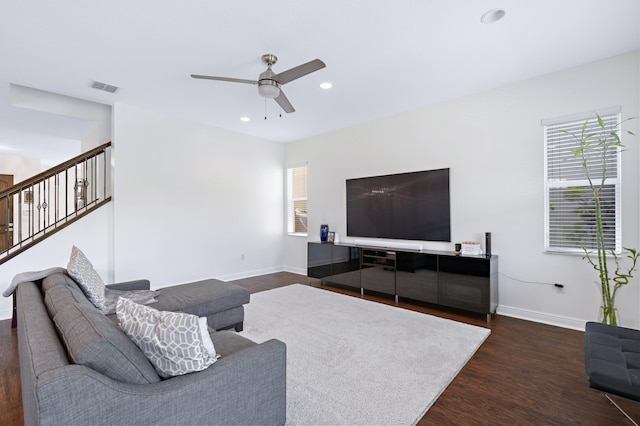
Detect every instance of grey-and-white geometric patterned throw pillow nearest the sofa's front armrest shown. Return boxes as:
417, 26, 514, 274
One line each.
116, 297, 219, 379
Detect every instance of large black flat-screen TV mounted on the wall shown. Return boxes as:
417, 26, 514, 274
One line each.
347, 169, 451, 241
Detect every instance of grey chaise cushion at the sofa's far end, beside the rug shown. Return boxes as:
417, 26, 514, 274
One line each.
153, 279, 250, 318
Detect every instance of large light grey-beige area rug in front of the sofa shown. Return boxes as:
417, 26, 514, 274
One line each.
242, 284, 490, 425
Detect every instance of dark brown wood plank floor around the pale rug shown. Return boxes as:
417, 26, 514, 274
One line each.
0, 272, 640, 425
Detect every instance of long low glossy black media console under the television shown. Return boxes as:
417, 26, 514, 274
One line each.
307, 242, 498, 321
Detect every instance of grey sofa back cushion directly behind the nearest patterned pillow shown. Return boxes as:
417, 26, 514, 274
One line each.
45, 285, 160, 384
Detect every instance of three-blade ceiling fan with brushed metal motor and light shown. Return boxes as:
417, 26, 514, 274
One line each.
191, 53, 326, 113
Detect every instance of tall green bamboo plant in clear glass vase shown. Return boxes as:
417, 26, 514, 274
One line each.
563, 114, 639, 325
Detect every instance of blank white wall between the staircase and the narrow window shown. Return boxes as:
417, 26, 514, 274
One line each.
114, 104, 284, 287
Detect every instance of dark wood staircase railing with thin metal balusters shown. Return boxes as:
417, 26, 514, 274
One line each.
0, 142, 111, 265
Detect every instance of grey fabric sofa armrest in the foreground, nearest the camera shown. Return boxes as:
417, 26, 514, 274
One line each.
31, 340, 286, 425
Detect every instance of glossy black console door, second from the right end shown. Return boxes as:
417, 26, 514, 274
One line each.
396, 252, 438, 303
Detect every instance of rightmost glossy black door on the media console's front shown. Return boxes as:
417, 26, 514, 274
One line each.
438, 256, 490, 314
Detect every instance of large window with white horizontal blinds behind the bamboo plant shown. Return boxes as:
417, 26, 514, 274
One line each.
543, 111, 621, 253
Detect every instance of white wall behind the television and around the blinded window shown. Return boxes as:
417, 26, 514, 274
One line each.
285, 51, 640, 328
